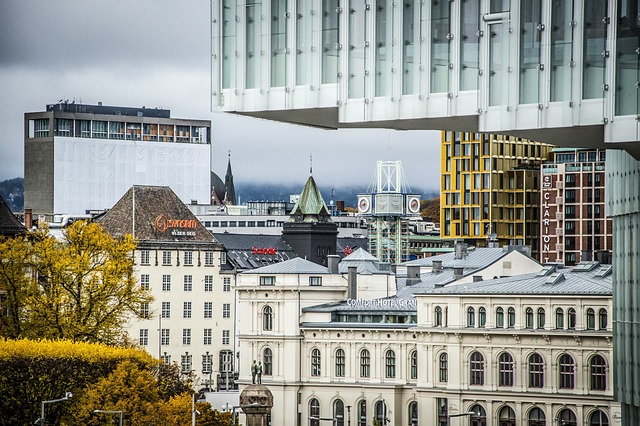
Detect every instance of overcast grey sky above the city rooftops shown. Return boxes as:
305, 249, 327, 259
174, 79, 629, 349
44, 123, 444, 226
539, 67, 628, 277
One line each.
0, 0, 440, 190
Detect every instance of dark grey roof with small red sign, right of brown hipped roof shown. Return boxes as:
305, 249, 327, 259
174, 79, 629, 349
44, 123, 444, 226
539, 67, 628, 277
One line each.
213, 232, 298, 269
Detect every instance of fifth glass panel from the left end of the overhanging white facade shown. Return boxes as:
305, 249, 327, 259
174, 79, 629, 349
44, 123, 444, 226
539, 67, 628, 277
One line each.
322, 0, 340, 84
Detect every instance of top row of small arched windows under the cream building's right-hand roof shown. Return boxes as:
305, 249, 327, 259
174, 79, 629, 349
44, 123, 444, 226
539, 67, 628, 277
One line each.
434, 306, 608, 330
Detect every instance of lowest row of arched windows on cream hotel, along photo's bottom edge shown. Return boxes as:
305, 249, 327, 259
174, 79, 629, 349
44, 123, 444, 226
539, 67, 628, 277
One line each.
309, 398, 609, 426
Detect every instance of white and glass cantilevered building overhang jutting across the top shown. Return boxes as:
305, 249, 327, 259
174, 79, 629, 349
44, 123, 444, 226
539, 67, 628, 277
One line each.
211, 0, 640, 152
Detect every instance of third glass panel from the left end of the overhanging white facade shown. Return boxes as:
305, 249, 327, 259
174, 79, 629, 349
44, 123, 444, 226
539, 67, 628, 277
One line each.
271, 0, 289, 87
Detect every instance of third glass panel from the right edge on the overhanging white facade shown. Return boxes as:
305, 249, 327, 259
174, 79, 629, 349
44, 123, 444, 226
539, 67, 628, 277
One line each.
549, 0, 573, 102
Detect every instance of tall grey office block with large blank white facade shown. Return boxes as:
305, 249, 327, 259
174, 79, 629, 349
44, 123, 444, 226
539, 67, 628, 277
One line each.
24, 102, 211, 219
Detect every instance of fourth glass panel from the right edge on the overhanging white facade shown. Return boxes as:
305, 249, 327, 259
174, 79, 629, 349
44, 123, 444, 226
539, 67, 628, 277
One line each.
519, 0, 542, 104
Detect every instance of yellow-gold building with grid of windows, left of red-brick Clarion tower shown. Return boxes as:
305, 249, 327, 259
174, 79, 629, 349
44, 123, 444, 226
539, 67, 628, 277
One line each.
440, 131, 553, 258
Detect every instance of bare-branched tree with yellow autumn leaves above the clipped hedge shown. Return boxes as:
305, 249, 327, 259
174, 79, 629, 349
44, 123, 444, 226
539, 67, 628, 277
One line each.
0, 221, 151, 344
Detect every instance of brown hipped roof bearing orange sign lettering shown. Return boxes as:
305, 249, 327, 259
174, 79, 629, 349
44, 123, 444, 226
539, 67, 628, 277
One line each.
99, 185, 215, 243
